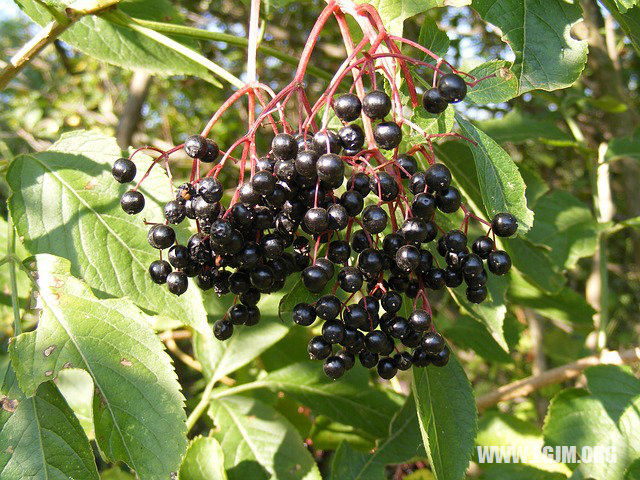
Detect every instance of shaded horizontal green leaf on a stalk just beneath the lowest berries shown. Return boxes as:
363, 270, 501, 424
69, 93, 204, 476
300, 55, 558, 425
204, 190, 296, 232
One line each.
214, 362, 398, 437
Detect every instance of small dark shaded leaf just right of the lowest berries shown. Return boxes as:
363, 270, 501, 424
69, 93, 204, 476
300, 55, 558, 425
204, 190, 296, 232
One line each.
438, 315, 513, 363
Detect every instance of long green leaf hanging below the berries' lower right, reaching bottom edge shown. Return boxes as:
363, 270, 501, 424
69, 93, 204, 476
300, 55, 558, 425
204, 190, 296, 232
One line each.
412, 354, 477, 480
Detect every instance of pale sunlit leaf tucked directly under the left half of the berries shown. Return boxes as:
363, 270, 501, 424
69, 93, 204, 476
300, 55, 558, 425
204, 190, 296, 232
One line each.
194, 289, 292, 381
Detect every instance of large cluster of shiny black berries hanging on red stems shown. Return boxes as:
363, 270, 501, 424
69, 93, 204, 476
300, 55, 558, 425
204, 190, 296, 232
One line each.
112, 74, 518, 379
